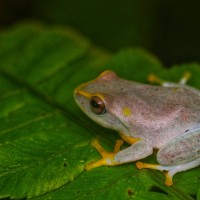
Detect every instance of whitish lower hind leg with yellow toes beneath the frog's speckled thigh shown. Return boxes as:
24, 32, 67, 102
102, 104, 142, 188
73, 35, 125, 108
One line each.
136, 158, 200, 186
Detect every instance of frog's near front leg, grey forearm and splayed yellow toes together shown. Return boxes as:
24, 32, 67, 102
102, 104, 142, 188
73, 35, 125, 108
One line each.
86, 140, 153, 170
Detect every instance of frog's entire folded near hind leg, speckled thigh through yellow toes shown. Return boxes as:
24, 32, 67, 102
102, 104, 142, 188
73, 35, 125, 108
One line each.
136, 128, 200, 186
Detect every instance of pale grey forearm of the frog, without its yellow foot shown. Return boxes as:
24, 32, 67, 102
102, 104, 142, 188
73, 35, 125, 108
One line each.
114, 140, 153, 163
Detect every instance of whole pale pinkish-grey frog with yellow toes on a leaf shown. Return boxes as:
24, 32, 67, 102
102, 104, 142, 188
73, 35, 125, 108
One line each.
74, 70, 200, 186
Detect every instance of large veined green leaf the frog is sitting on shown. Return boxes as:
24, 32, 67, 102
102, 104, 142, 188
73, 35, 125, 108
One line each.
0, 23, 200, 200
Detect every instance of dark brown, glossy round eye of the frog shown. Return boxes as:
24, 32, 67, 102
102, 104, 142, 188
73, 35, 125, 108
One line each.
90, 96, 106, 115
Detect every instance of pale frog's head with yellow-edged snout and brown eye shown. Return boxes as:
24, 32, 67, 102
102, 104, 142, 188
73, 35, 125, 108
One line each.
74, 70, 130, 132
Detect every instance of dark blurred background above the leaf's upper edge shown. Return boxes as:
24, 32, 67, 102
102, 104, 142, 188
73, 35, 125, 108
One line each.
0, 0, 200, 66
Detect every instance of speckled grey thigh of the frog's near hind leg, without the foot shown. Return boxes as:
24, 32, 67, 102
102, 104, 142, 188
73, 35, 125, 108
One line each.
157, 128, 200, 166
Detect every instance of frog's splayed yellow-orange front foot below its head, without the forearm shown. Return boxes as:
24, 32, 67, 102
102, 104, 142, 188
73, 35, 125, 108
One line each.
85, 139, 123, 171
